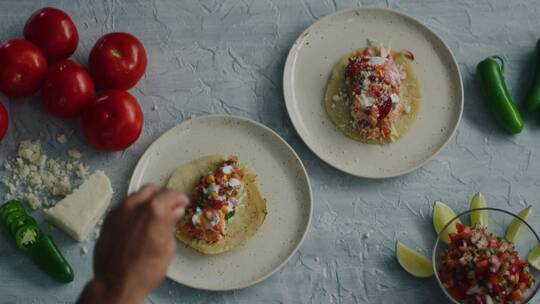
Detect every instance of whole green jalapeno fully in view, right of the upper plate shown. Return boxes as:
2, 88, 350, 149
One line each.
477, 56, 523, 134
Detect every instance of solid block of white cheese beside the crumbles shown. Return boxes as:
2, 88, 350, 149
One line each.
44, 170, 113, 242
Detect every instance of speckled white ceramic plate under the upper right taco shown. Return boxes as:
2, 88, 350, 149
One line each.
283, 8, 463, 178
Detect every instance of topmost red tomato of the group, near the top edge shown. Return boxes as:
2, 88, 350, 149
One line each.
24, 7, 79, 61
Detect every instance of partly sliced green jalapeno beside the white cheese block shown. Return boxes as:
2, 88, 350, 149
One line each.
0, 200, 74, 283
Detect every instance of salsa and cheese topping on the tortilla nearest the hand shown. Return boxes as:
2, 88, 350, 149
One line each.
180, 156, 244, 242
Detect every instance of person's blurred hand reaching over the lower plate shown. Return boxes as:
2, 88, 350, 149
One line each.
79, 185, 189, 303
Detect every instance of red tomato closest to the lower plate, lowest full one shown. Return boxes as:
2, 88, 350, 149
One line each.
82, 90, 143, 151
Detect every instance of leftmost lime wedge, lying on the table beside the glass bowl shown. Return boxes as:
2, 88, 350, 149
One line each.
396, 241, 433, 278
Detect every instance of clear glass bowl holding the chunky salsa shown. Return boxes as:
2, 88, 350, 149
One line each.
432, 208, 540, 304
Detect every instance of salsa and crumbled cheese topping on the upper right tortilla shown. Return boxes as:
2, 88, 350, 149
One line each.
333, 45, 414, 140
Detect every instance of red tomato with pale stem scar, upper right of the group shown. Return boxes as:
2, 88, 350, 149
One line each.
88, 33, 146, 90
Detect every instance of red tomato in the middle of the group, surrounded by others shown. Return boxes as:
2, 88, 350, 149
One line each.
41, 60, 94, 117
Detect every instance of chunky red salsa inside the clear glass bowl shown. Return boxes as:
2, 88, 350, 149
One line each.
439, 223, 534, 304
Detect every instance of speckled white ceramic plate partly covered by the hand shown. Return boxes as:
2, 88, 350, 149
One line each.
128, 115, 312, 290
